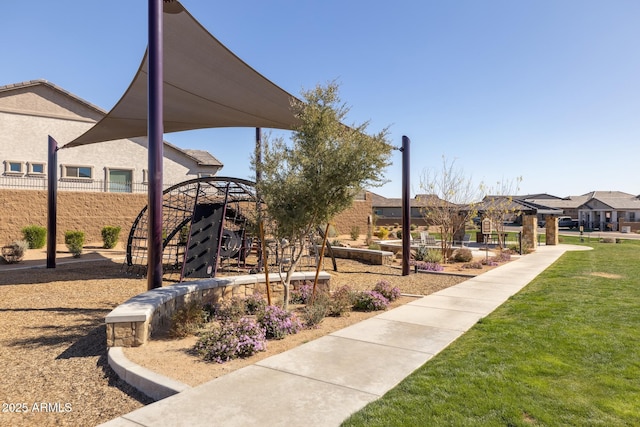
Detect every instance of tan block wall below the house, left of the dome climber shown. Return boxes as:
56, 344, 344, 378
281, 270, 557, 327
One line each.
0, 189, 147, 245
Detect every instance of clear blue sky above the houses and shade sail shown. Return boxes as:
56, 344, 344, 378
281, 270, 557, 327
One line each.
0, 0, 640, 197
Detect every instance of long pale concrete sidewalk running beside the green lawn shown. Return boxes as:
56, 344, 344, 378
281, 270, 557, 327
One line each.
103, 245, 590, 427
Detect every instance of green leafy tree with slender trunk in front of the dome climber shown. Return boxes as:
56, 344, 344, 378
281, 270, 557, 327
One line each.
252, 82, 393, 308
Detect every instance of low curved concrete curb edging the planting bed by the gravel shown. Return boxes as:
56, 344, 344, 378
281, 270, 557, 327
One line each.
107, 347, 191, 401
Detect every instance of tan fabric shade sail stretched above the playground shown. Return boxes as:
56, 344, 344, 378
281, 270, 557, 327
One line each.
63, 1, 298, 148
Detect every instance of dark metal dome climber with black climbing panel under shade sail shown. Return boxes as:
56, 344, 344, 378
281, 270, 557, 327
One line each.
126, 177, 257, 281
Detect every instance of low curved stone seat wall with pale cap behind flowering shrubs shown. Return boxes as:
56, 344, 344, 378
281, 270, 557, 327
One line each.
105, 271, 331, 347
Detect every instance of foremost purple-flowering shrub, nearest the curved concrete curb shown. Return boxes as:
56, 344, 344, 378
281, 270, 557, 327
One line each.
194, 317, 267, 363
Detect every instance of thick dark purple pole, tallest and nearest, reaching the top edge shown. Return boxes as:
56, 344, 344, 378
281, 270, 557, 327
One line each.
147, 0, 164, 289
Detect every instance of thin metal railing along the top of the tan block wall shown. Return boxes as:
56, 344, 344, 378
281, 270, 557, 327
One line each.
0, 176, 173, 193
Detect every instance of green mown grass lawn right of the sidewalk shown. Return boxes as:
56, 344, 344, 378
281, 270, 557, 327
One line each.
343, 238, 640, 427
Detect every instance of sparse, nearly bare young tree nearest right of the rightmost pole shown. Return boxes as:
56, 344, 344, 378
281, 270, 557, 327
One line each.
420, 156, 479, 263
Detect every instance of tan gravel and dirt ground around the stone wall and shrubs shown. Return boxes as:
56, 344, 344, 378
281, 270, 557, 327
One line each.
0, 242, 496, 426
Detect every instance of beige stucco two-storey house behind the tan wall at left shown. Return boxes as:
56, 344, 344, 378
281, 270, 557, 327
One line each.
0, 80, 223, 192
